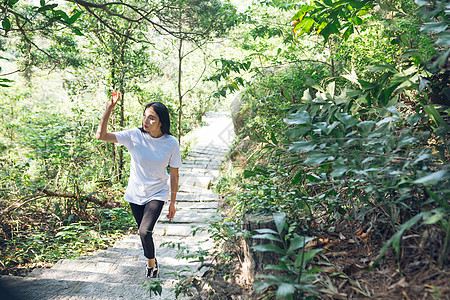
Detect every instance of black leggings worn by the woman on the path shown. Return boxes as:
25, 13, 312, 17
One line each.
130, 200, 164, 259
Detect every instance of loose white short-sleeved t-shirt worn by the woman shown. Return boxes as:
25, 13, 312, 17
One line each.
114, 128, 181, 205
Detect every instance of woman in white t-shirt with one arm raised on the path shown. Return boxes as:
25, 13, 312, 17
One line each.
96, 91, 181, 278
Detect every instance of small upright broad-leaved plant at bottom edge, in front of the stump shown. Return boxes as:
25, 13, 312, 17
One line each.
252, 213, 323, 299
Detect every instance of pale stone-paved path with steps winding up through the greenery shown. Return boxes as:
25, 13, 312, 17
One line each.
0, 113, 233, 300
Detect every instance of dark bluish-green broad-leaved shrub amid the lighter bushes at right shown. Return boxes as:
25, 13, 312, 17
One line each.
286, 77, 448, 223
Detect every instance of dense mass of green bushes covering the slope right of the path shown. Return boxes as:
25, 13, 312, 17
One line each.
217, 1, 450, 298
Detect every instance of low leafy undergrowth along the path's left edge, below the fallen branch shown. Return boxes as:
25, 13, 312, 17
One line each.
0, 208, 134, 273
